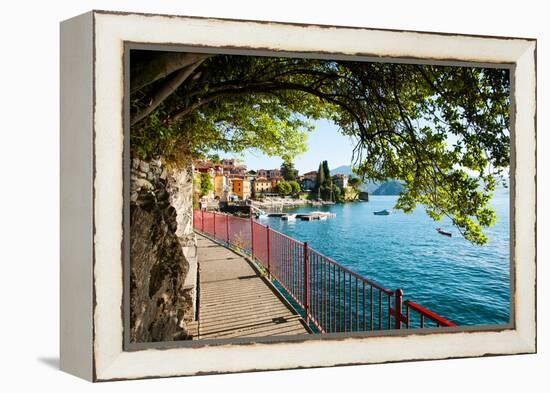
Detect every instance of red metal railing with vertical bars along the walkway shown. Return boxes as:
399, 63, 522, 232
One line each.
193, 211, 456, 333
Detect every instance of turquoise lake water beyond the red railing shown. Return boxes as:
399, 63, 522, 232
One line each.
262, 191, 510, 325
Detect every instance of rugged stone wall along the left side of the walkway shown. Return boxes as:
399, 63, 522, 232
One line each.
130, 159, 197, 342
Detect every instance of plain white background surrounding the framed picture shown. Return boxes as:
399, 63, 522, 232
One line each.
0, 0, 550, 393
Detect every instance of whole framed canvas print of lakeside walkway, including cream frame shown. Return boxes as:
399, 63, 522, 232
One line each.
61, 11, 536, 381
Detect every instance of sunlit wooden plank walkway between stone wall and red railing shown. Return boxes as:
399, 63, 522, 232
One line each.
197, 234, 309, 339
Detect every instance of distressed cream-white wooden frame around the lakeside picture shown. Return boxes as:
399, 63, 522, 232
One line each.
61, 11, 536, 381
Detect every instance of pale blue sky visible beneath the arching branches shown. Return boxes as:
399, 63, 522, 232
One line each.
239, 120, 355, 174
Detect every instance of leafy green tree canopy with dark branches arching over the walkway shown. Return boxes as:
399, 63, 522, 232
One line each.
130, 51, 510, 244
